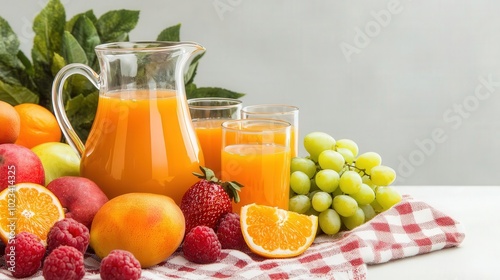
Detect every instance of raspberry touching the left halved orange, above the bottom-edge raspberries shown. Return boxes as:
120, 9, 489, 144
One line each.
47, 218, 89, 254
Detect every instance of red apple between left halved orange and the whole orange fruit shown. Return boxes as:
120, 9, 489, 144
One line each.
47, 176, 108, 229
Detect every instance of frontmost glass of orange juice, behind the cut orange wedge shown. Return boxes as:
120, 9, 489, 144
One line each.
221, 119, 291, 213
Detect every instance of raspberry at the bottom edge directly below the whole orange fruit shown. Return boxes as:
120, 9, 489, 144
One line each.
101, 250, 141, 280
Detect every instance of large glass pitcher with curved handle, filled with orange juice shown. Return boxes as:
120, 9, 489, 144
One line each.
52, 42, 205, 204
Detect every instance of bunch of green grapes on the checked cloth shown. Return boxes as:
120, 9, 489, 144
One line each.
289, 132, 402, 235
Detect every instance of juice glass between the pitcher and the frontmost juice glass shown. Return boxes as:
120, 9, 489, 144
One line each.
188, 97, 242, 178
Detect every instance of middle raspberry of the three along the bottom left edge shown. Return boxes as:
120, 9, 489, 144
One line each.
42, 245, 85, 280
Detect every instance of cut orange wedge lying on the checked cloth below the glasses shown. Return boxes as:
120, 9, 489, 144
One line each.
240, 203, 318, 258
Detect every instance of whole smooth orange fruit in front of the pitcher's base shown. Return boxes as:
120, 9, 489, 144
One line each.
90, 193, 185, 268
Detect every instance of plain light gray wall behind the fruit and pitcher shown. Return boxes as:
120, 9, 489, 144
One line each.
4, 0, 500, 185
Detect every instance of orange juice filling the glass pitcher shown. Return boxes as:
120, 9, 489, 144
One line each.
81, 90, 199, 201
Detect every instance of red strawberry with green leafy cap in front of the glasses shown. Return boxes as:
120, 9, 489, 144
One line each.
180, 166, 242, 233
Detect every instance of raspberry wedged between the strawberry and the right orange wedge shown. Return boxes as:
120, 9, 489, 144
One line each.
217, 213, 246, 250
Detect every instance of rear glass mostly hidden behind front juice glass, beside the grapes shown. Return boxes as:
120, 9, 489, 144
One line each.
241, 104, 299, 157
